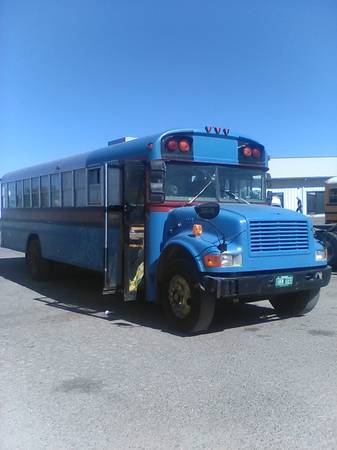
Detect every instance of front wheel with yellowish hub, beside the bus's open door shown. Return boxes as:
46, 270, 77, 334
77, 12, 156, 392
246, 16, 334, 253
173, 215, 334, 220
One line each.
160, 259, 215, 333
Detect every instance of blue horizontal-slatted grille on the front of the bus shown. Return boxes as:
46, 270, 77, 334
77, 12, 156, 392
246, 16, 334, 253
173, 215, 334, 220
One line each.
250, 220, 309, 255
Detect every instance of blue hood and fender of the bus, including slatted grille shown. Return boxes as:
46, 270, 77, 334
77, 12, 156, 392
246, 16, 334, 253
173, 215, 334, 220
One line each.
164, 203, 318, 272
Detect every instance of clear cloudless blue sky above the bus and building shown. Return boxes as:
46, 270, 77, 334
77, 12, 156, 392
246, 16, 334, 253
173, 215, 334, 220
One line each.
0, 0, 337, 175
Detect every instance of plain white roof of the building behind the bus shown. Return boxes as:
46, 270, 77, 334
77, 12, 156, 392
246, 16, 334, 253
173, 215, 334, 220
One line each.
269, 156, 337, 179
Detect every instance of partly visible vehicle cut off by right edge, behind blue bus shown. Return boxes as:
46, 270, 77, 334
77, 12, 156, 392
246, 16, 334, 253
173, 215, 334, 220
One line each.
315, 177, 337, 270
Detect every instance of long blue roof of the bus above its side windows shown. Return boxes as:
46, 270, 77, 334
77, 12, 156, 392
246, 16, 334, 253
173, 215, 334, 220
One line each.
1, 129, 258, 182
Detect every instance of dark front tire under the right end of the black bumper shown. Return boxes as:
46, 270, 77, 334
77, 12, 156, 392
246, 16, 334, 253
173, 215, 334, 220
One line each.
269, 289, 319, 317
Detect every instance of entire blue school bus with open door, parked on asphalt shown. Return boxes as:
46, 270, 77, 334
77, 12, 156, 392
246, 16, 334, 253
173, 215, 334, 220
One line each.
1, 127, 330, 332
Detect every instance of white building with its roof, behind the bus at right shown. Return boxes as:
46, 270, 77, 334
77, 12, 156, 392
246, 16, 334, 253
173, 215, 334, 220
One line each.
269, 156, 337, 216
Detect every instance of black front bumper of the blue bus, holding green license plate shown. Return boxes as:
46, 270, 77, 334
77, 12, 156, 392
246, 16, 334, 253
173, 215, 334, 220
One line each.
201, 266, 331, 299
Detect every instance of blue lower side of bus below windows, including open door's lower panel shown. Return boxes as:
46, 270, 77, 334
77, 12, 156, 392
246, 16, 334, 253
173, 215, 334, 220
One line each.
2, 208, 122, 278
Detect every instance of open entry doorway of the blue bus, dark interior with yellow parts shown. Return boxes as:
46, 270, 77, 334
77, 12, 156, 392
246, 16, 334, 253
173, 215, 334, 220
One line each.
123, 161, 145, 301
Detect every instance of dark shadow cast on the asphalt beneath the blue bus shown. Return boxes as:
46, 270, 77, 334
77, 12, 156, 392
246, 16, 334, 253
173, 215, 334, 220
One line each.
0, 257, 281, 337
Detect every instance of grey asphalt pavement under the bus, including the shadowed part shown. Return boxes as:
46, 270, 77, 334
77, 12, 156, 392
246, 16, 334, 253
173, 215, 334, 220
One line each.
0, 249, 337, 450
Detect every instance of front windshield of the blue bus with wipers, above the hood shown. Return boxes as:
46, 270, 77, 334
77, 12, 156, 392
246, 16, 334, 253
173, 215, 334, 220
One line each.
165, 162, 265, 202
